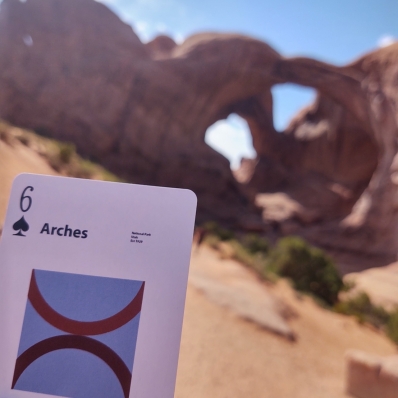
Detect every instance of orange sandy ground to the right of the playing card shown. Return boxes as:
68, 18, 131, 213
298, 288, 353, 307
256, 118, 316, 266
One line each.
175, 246, 396, 398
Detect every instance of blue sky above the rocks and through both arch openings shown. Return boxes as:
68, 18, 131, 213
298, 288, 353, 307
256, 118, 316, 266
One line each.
98, 0, 398, 166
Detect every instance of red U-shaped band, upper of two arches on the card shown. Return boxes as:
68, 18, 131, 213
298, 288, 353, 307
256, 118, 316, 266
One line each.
28, 270, 145, 336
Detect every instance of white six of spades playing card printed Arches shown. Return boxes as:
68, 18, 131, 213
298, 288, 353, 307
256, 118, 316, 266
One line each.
0, 174, 196, 398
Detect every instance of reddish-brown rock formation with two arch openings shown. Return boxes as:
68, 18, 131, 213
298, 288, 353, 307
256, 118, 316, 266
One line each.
0, 0, 398, 258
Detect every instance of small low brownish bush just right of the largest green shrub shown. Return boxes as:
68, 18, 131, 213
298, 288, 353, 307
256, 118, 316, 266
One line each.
333, 292, 390, 326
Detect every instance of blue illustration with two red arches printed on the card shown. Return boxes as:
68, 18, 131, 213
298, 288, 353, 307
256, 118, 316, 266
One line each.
12, 270, 145, 398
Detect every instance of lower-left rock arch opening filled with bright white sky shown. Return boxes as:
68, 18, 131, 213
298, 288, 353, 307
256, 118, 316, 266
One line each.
205, 113, 257, 170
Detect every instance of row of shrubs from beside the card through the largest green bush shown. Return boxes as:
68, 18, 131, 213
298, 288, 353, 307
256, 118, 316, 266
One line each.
203, 227, 345, 306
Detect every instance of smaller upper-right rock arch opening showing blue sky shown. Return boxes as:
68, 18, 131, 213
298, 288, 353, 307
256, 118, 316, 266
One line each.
271, 83, 317, 131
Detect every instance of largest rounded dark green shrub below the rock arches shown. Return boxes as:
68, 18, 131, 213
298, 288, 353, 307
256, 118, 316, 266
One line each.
269, 237, 344, 305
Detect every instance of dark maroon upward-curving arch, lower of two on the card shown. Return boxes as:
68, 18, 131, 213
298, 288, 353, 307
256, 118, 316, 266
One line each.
11, 335, 131, 398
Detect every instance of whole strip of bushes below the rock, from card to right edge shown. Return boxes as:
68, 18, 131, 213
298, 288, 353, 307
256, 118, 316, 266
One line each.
203, 227, 398, 344
